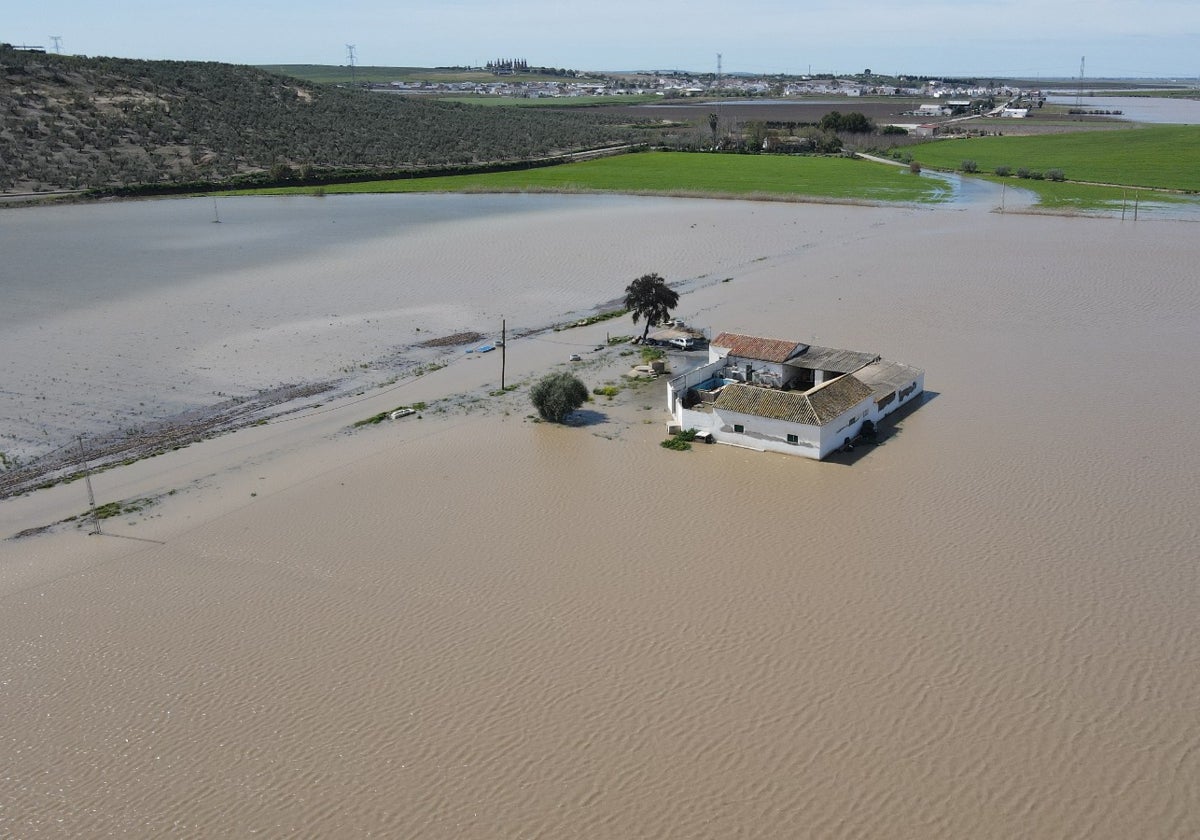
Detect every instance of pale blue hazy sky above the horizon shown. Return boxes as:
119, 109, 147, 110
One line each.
9, 0, 1200, 83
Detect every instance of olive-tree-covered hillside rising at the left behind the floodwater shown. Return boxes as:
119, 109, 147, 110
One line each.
0, 46, 631, 192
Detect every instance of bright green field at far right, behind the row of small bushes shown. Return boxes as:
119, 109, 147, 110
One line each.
906, 126, 1200, 192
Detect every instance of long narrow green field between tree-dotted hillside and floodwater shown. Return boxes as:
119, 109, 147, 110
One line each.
234, 151, 946, 202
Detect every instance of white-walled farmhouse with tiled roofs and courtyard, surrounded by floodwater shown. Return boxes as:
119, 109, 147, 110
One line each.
667, 332, 925, 460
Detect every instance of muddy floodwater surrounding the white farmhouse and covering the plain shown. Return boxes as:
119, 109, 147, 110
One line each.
0, 196, 1200, 840
